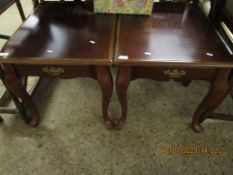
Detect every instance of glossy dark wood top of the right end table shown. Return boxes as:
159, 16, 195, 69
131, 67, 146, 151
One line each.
114, 4, 233, 67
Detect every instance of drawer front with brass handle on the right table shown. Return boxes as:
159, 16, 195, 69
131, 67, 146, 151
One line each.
132, 67, 217, 81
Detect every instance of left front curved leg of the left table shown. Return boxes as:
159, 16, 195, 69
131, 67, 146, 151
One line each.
3, 64, 39, 126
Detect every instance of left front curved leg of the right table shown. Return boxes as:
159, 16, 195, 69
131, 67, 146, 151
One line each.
115, 66, 131, 129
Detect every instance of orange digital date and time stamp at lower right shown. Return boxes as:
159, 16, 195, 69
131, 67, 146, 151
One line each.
160, 147, 220, 155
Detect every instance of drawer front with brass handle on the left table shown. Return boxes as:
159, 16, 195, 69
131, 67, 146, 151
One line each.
14, 65, 95, 78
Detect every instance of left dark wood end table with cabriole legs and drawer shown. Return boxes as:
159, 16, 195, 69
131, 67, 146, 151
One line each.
0, 2, 116, 128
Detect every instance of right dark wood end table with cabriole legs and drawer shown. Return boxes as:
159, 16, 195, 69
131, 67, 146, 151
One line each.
115, 3, 233, 132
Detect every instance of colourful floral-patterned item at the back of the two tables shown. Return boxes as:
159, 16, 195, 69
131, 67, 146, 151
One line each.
94, 0, 154, 15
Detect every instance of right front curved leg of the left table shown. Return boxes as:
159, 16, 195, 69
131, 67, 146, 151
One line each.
96, 66, 114, 129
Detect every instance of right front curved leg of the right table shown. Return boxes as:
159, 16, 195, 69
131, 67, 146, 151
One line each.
192, 69, 233, 132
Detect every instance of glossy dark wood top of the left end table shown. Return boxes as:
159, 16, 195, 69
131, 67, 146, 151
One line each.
0, 2, 116, 65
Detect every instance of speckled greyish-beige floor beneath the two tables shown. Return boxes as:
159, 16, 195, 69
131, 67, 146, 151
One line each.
0, 0, 233, 175
